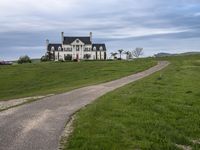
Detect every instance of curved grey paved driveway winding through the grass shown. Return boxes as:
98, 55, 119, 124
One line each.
0, 61, 169, 150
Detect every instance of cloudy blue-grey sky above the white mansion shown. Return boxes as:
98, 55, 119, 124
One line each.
0, 0, 200, 60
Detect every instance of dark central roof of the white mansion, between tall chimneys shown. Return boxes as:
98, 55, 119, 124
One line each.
63, 37, 92, 44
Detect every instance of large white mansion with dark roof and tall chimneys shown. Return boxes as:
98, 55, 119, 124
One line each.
46, 32, 107, 61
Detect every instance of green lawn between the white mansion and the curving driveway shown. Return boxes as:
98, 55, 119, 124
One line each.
0, 59, 156, 100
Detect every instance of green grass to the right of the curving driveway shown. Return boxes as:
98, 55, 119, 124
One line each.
65, 55, 200, 150
